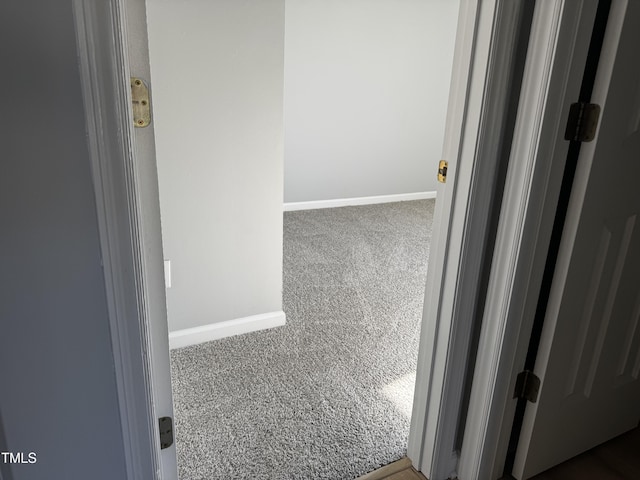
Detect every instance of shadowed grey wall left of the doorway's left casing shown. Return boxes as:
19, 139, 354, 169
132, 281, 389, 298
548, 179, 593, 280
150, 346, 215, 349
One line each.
0, 0, 125, 480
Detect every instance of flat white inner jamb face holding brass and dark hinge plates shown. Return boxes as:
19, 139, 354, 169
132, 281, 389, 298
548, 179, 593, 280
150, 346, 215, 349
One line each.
122, 0, 178, 480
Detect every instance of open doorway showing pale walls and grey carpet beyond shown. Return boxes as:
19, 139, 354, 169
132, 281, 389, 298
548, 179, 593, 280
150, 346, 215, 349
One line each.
147, 1, 458, 478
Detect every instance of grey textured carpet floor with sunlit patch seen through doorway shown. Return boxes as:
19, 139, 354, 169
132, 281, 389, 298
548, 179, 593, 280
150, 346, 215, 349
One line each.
171, 200, 434, 480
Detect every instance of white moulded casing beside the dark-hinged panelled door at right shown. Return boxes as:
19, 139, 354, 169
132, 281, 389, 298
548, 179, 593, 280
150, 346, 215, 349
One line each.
458, 0, 597, 480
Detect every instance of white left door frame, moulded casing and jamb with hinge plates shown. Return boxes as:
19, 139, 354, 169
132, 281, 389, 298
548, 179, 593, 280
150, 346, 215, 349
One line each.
73, 0, 177, 480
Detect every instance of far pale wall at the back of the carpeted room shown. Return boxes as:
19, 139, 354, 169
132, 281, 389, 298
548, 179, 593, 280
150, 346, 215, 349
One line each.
284, 0, 459, 202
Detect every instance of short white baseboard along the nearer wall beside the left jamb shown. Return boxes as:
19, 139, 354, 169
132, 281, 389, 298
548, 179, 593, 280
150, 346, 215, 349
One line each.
169, 310, 286, 350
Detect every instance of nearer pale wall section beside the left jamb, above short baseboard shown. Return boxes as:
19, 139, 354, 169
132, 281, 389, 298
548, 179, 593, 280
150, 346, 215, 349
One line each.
147, 0, 284, 332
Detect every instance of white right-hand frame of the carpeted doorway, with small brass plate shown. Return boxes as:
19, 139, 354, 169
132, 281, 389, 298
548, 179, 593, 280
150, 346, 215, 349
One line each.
408, 0, 536, 480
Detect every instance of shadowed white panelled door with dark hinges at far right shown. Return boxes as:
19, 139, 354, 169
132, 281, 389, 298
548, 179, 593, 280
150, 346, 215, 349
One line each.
513, 0, 640, 479
